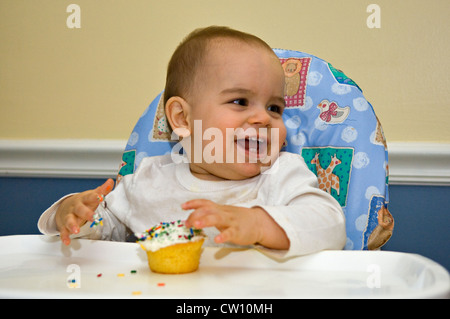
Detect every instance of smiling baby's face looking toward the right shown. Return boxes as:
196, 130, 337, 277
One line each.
188, 40, 286, 180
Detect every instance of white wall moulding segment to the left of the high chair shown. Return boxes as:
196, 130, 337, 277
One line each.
0, 140, 127, 178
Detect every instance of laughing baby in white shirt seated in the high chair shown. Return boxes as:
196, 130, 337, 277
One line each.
38, 27, 346, 257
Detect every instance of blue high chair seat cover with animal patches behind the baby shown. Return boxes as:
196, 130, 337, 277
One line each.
117, 49, 394, 250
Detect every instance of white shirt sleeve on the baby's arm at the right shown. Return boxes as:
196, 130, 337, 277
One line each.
255, 154, 347, 258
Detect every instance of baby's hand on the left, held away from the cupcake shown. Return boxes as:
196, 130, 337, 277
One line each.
55, 179, 114, 245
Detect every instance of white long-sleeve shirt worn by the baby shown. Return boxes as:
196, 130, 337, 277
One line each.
38, 152, 346, 258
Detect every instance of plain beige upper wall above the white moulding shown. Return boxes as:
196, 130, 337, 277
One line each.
0, 0, 450, 143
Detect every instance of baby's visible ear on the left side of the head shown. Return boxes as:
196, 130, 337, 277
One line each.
165, 96, 191, 137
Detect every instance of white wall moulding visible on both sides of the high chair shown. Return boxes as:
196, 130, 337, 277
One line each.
0, 140, 450, 185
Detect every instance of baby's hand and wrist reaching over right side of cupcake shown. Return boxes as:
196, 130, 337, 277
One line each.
181, 199, 289, 249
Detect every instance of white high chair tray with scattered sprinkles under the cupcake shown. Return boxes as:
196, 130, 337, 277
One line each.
0, 235, 450, 298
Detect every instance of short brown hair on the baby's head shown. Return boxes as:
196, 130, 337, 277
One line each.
164, 26, 275, 105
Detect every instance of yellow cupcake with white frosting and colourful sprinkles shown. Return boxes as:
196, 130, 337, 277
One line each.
135, 220, 205, 274
